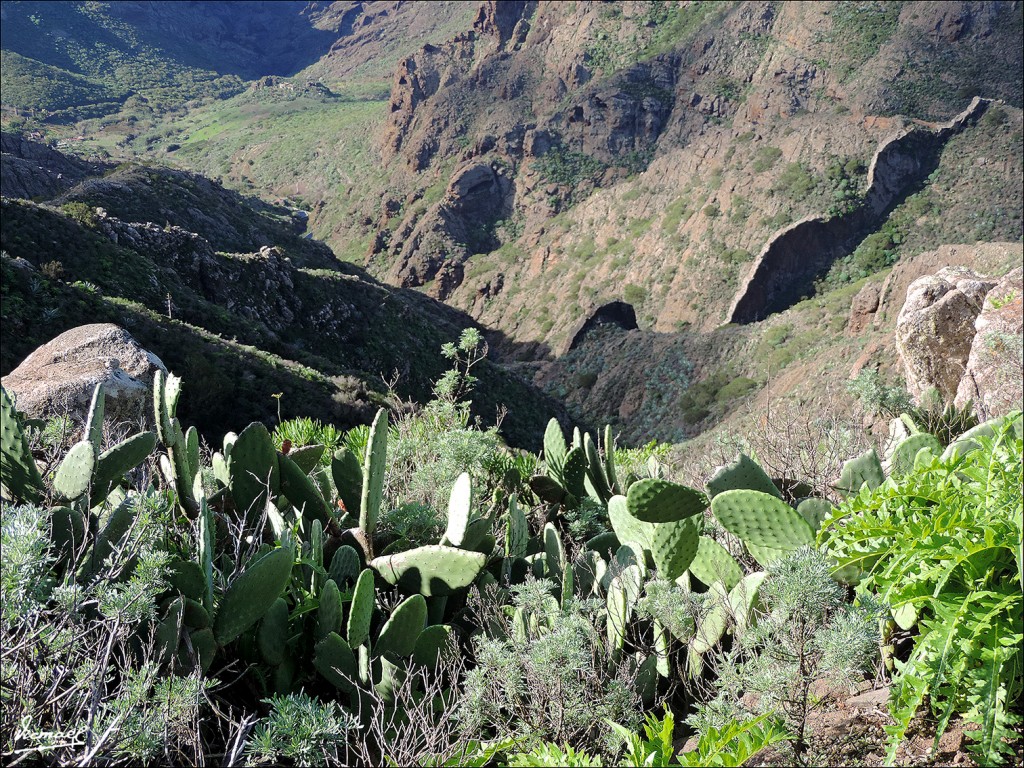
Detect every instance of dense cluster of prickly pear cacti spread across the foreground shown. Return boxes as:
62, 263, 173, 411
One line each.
2, 374, 1019, 768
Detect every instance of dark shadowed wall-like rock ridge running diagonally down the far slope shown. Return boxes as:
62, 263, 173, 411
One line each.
728, 97, 990, 323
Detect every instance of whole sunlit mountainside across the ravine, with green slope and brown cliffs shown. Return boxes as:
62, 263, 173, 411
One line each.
5, 0, 1024, 439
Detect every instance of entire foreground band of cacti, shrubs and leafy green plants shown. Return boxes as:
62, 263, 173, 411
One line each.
0, 331, 1024, 766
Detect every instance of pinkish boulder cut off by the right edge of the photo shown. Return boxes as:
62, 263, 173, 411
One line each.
956, 267, 1024, 419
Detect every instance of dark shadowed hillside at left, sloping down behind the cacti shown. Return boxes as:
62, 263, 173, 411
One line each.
0, 139, 558, 444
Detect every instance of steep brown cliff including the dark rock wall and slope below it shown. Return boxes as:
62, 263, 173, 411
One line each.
348, 2, 1022, 436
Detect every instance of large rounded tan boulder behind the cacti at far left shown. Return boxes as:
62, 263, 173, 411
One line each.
3, 323, 167, 425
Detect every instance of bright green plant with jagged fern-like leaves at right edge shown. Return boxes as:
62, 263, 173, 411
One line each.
819, 414, 1024, 765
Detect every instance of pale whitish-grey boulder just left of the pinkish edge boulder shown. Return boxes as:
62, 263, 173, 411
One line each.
896, 267, 995, 400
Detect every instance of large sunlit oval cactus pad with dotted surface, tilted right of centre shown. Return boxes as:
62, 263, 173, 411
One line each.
711, 490, 814, 550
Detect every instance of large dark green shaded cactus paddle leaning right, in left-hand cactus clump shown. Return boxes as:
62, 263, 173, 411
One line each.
213, 547, 295, 647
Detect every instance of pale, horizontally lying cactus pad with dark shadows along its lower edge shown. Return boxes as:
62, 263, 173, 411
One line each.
370, 545, 487, 597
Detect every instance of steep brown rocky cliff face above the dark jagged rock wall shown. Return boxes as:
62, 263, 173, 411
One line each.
364, 2, 1020, 349
